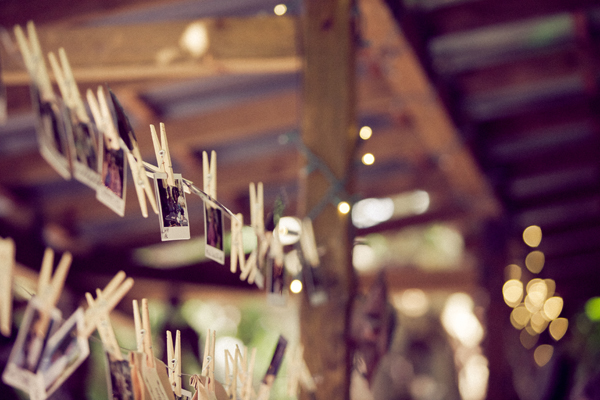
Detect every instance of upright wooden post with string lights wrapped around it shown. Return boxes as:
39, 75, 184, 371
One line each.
298, 0, 357, 400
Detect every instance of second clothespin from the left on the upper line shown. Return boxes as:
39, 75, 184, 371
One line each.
48, 47, 91, 124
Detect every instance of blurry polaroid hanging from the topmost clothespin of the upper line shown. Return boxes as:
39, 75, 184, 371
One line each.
31, 85, 71, 179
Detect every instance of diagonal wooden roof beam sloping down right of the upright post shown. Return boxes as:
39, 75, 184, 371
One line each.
359, 0, 500, 222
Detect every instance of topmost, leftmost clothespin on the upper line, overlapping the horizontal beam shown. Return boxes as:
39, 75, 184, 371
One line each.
14, 21, 55, 101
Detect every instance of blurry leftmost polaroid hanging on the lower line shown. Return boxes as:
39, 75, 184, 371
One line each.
2, 297, 61, 393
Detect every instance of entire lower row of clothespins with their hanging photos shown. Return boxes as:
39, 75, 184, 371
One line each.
0, 239, 315, 400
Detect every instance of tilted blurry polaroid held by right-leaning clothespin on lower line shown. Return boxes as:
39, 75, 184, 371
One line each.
37, 308, 90, 398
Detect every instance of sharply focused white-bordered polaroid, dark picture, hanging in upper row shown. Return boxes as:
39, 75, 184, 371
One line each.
154, 172, 190, 241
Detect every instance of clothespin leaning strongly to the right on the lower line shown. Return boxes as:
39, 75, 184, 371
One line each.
84, 271, 133, 337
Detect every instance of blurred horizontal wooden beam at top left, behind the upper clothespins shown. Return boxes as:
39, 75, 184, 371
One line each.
0, 16, 301, 86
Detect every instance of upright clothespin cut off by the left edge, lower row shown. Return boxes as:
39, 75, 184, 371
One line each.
0, 238, 15, 337
